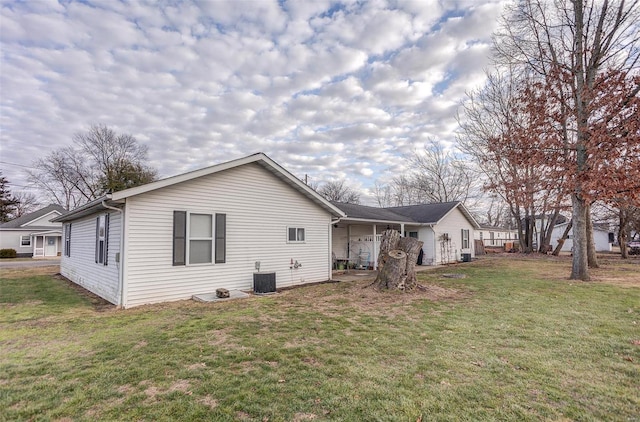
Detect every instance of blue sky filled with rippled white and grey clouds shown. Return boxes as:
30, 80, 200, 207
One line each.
0, 0, 502, 202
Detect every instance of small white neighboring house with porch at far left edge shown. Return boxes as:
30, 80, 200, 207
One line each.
0, 204, 67, 258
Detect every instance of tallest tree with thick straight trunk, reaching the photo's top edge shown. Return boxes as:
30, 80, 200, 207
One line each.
494, 0, 640, 280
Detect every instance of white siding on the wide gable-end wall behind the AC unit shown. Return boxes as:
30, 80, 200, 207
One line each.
124, 163, 331, 307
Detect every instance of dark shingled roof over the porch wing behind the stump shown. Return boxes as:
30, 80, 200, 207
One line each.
334, 202, 480, 228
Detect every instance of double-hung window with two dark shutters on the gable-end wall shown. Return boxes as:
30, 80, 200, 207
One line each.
173, 211, 227, 265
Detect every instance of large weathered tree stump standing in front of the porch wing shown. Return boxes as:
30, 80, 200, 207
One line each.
372, 230, 424, 291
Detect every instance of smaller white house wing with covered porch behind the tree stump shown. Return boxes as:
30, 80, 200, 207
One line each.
332, 202, 480, 268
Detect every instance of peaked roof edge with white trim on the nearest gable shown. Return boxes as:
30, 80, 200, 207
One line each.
54, 152, 344, 221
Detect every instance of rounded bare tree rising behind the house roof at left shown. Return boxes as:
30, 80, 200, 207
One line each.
28, 125, 156, 209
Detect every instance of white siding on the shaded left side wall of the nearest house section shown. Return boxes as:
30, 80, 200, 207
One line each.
60, 212, 121, 304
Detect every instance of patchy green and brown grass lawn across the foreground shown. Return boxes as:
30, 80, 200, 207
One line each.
0, 256, 640, 421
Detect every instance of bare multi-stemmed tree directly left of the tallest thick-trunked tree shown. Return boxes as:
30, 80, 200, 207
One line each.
458, 70, 563, 252
